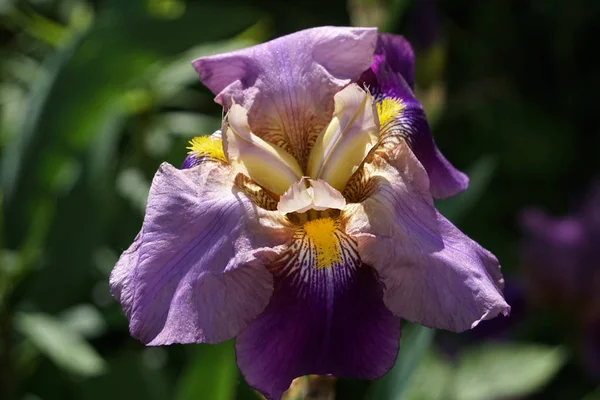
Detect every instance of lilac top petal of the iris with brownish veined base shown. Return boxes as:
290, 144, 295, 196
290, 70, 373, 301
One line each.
192, 27, 377, 165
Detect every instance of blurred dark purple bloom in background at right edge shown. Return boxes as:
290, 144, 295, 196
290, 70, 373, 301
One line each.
522, 181, 600, 380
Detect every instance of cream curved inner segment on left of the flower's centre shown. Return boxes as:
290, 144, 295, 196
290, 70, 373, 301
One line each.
223, 104, 302, 195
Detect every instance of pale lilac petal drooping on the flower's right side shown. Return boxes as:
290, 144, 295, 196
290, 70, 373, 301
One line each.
344, 144, 510, 331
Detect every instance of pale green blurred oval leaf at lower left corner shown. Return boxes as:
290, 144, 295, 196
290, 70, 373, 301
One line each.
15, 313, 106, 377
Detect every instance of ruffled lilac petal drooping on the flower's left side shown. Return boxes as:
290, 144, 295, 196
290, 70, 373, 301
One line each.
110, 162, 287, 345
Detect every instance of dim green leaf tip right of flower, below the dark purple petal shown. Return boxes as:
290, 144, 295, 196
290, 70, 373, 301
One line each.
436, 156, 496, 223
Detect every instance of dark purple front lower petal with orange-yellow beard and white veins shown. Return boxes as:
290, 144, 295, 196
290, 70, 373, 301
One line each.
236, 219, 400, 399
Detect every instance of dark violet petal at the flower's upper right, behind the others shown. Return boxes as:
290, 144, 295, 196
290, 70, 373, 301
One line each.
360, 34, 469, 198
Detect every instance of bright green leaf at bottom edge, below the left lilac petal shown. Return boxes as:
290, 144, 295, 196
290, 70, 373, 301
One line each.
175, 341, 238, 400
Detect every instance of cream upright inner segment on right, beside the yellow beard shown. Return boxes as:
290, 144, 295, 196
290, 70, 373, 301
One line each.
308, 84, 379, 191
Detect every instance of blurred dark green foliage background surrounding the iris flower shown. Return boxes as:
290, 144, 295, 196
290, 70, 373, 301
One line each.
0, 0, 600, 400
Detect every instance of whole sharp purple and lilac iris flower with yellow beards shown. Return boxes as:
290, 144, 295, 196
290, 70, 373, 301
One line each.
111, 27, 510, 399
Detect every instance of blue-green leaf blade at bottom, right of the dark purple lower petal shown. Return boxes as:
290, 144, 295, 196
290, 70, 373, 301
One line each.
368, 325, 435, 400
